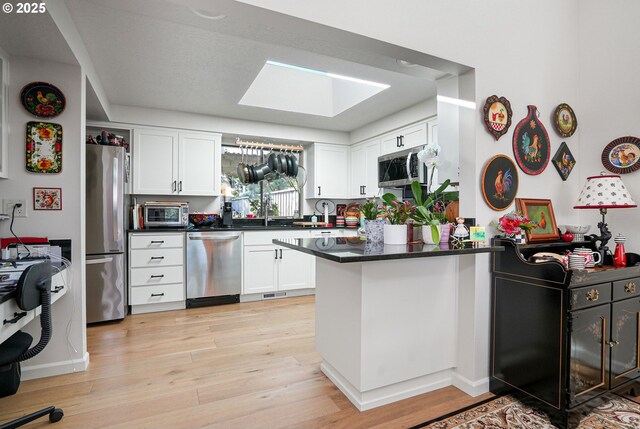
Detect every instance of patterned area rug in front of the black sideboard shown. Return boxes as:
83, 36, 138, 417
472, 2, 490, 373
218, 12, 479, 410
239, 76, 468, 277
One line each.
412, 395, 640, 429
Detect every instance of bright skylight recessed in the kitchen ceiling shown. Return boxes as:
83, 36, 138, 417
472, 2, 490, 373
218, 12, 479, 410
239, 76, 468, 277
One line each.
239, 61, 389, 117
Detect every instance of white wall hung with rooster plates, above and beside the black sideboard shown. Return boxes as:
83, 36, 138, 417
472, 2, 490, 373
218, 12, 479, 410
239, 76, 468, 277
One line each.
241, 0, 584, 393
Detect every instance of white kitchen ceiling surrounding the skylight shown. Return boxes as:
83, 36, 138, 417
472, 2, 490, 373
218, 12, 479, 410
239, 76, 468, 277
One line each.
62, 0, 446, 131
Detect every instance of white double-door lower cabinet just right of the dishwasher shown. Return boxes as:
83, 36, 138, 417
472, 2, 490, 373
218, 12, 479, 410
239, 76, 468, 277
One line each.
242, 231, 315, 295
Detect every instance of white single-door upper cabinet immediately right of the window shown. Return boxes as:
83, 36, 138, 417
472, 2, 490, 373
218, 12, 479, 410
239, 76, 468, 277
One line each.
305, 143, 349, 198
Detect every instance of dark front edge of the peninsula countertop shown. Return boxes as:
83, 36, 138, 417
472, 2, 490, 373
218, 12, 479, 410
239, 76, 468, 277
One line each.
272, 239, 505, 264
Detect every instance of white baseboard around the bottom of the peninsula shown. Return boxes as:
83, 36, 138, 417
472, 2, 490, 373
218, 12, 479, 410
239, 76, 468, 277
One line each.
320, 361, 453, 411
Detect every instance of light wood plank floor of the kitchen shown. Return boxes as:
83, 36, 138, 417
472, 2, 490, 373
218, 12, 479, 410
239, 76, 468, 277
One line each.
0, 296, 490, 429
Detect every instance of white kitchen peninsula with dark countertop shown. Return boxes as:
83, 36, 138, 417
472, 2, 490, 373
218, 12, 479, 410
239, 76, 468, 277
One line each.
273, 237, 504, 411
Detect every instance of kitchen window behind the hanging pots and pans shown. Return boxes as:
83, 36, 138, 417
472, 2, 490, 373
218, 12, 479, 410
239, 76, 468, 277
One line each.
222, 146, 302, 219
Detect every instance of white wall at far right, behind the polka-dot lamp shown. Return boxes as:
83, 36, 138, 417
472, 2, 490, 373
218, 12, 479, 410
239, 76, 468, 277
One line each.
574, 0, 640, 253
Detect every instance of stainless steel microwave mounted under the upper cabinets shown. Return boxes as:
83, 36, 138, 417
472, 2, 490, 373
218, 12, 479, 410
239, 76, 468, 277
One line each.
378, 147, 427, 188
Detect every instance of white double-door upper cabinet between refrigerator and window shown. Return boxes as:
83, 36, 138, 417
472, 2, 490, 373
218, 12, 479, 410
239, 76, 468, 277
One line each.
132, 128, 221, 196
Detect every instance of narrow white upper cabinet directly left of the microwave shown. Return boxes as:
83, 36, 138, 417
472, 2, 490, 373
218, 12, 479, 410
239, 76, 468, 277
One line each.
349, 138, 380, 198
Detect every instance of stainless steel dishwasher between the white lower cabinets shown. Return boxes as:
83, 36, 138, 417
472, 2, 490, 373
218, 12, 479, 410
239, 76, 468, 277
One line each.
187, 231, 242, 308
